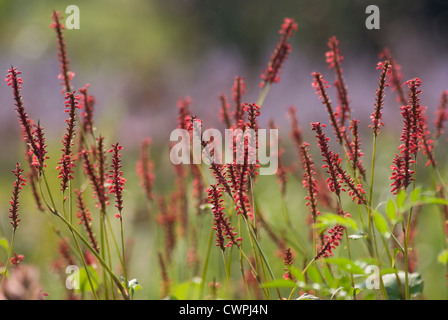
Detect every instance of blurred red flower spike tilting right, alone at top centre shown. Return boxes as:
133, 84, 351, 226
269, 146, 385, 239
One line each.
260, 18, 297, 88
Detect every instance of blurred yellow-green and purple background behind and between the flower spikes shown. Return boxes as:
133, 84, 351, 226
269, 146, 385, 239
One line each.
0, 0, 448, 299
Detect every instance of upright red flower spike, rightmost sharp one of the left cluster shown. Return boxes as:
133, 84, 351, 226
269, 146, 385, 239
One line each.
107, 143, 126, 219
